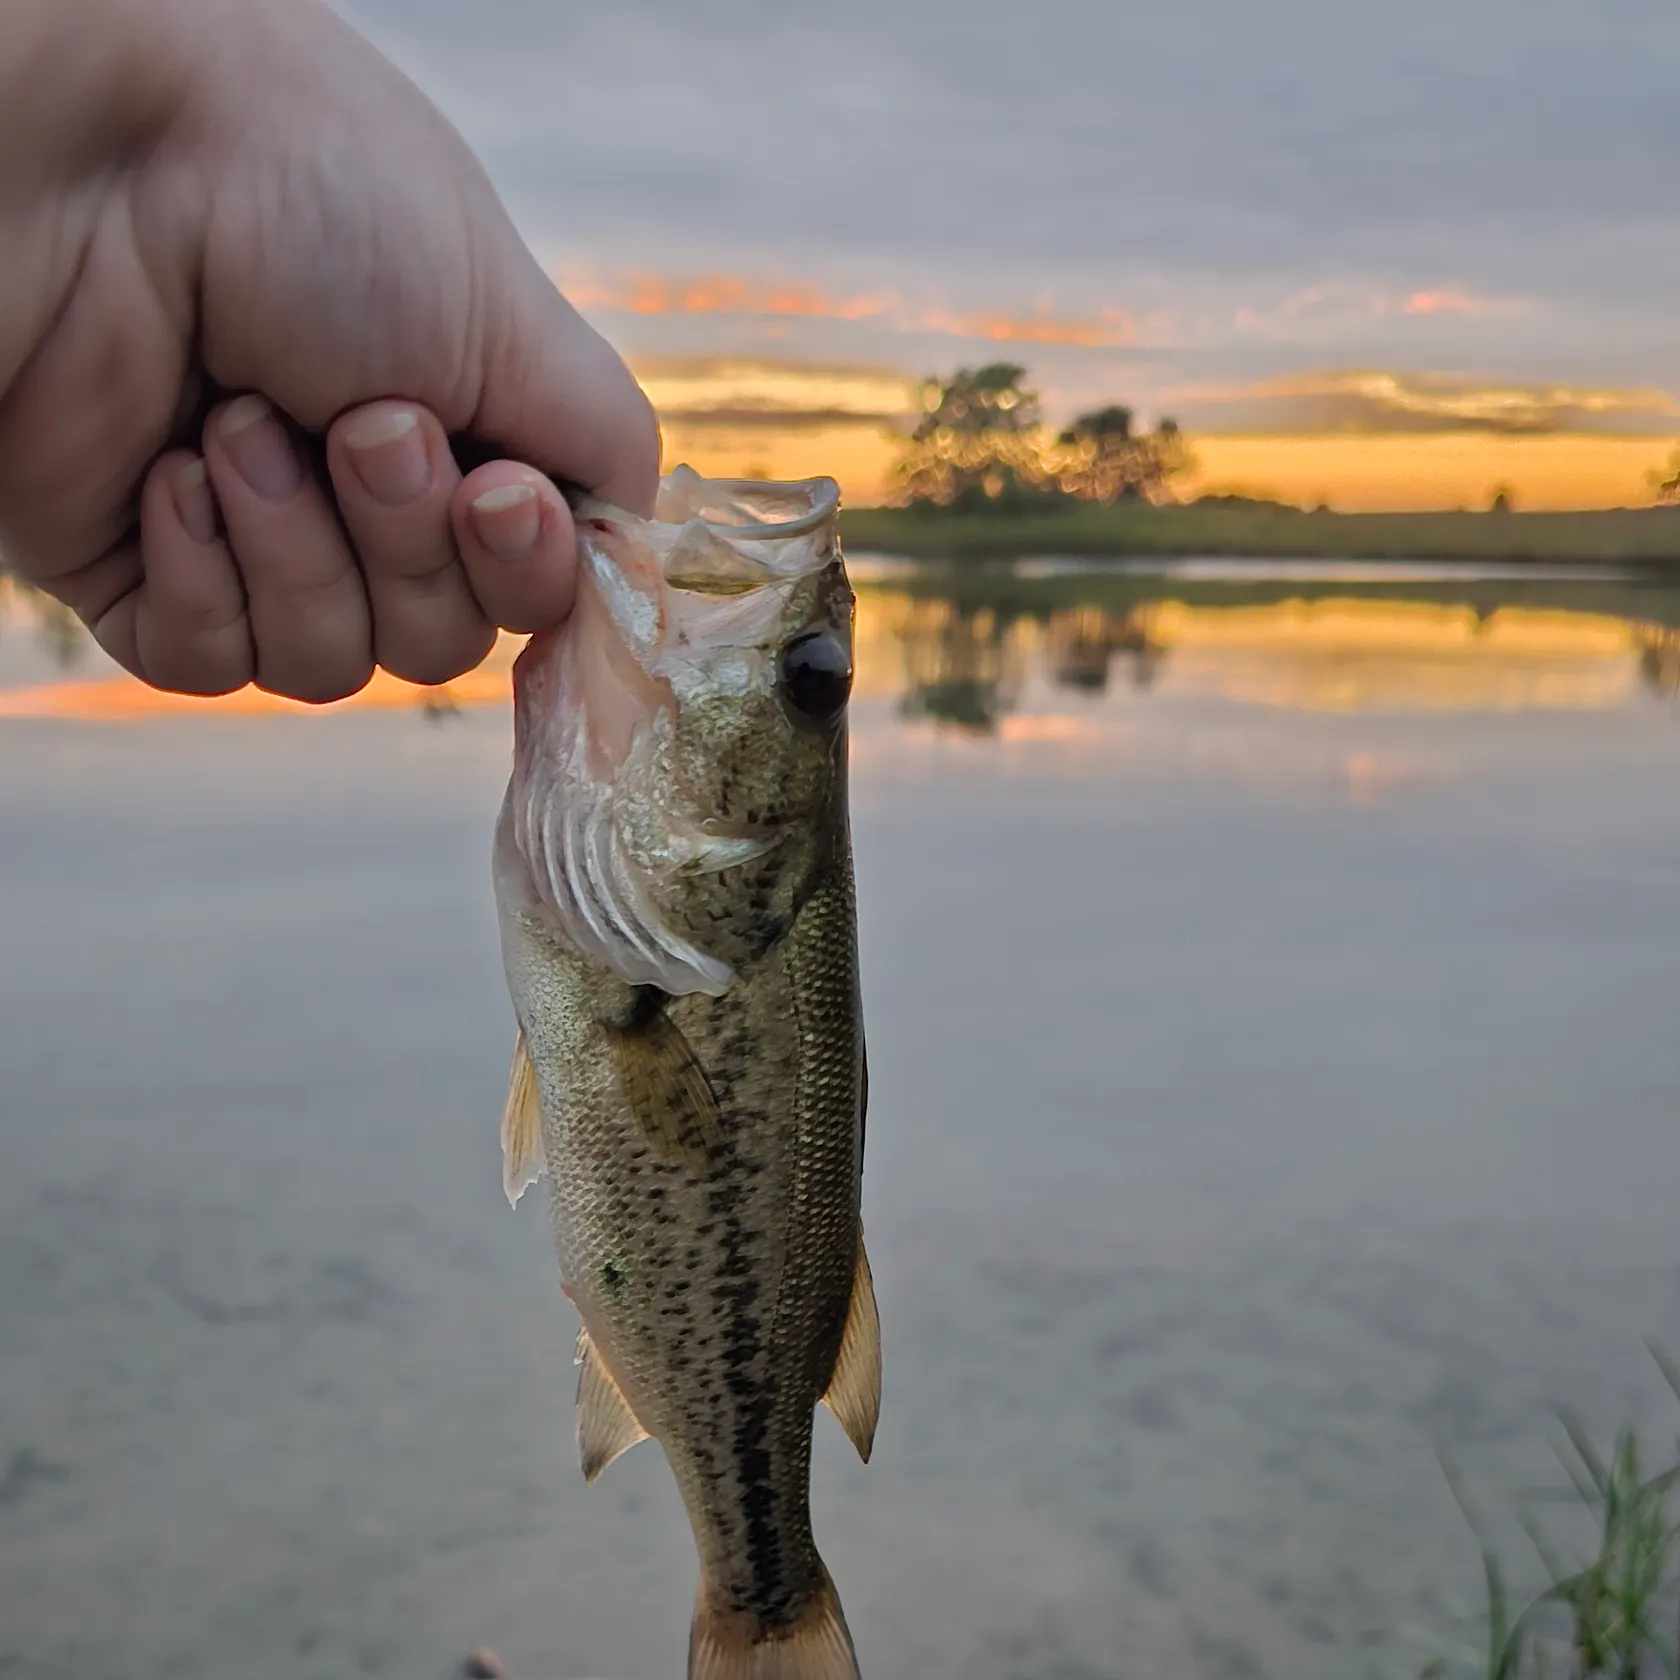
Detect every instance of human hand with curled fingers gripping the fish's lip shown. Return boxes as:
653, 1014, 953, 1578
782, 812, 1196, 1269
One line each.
0, 0, 659, 701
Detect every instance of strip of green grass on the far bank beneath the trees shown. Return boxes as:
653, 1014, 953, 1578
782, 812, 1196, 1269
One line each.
840, 502, 1680, 568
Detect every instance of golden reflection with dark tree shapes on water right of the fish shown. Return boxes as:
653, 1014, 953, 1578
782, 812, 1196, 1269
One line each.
860, 585, 1680, 734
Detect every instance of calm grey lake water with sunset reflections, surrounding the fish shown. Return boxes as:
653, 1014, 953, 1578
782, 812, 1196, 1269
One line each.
0, 564, 1680, 1680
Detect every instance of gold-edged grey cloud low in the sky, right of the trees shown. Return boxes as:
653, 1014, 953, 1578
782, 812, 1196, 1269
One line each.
1163, 368, 1680, 433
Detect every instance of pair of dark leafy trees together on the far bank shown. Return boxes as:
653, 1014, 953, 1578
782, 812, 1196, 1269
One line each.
895, 361, 1191, 512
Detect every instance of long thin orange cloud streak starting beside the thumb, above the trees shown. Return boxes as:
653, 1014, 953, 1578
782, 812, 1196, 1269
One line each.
558, 269, 1137, 346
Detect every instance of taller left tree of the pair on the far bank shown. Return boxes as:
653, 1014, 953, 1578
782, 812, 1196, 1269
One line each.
897, 361, 1055, 512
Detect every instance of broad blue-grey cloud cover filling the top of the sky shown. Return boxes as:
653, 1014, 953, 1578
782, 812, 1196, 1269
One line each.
341, 0, 1680, 297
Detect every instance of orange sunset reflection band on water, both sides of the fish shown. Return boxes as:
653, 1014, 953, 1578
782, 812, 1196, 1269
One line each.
0, 563, 1680, 738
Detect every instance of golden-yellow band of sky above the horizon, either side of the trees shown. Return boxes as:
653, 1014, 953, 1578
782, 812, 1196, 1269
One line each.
614, 353, 1680, 512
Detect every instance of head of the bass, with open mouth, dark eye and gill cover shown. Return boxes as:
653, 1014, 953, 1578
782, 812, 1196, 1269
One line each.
497, 467, 853, 995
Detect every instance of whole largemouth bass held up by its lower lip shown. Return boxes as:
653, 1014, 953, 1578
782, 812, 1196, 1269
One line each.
494, 467, 882, 1680
